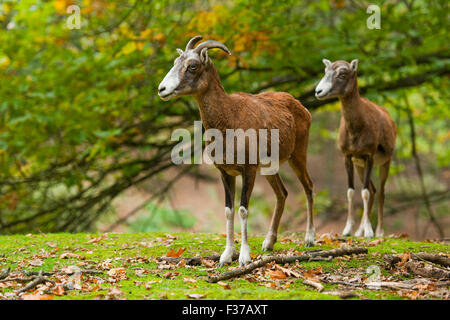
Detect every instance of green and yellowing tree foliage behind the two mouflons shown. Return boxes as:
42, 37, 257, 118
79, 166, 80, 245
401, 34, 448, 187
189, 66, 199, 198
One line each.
0, 0, 450, 233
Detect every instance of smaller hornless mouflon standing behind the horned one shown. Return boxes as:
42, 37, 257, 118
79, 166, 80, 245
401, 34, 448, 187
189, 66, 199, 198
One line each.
315, 59, 397, 238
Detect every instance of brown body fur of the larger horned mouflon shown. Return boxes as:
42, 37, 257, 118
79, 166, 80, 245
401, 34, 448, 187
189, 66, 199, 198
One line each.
194, 62, 313, 249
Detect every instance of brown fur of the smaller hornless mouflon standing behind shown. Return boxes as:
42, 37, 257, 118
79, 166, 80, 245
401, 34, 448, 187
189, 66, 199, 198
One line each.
318, 60, 397, 235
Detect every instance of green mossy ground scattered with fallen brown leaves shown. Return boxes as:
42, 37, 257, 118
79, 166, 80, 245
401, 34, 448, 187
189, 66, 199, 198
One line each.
0, 233, 449, 300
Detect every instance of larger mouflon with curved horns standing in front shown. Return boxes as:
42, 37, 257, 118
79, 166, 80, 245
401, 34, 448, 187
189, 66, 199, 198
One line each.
158, 36, 315, 265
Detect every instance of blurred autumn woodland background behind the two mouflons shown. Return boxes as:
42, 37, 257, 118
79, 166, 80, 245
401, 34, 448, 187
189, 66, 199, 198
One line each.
0, 0, 450, 239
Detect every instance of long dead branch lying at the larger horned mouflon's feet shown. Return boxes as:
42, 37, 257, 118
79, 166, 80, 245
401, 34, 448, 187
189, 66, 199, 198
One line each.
207, 247, 368, 283
